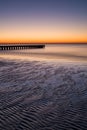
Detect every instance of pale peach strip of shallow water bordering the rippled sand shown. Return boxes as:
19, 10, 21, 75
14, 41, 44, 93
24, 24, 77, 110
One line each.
0, 53, 87, 64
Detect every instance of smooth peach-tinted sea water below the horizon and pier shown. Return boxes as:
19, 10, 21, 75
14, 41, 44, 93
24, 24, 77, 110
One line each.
0, 45, 87, 61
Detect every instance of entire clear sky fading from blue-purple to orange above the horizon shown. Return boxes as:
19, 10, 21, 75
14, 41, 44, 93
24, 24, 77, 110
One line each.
0, 0, 87, 43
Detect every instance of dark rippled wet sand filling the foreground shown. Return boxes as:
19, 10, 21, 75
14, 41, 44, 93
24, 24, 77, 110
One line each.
0, 59, 87, 130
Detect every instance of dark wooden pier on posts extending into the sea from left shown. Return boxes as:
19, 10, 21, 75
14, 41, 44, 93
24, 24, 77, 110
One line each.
0, 44, 45, 50
